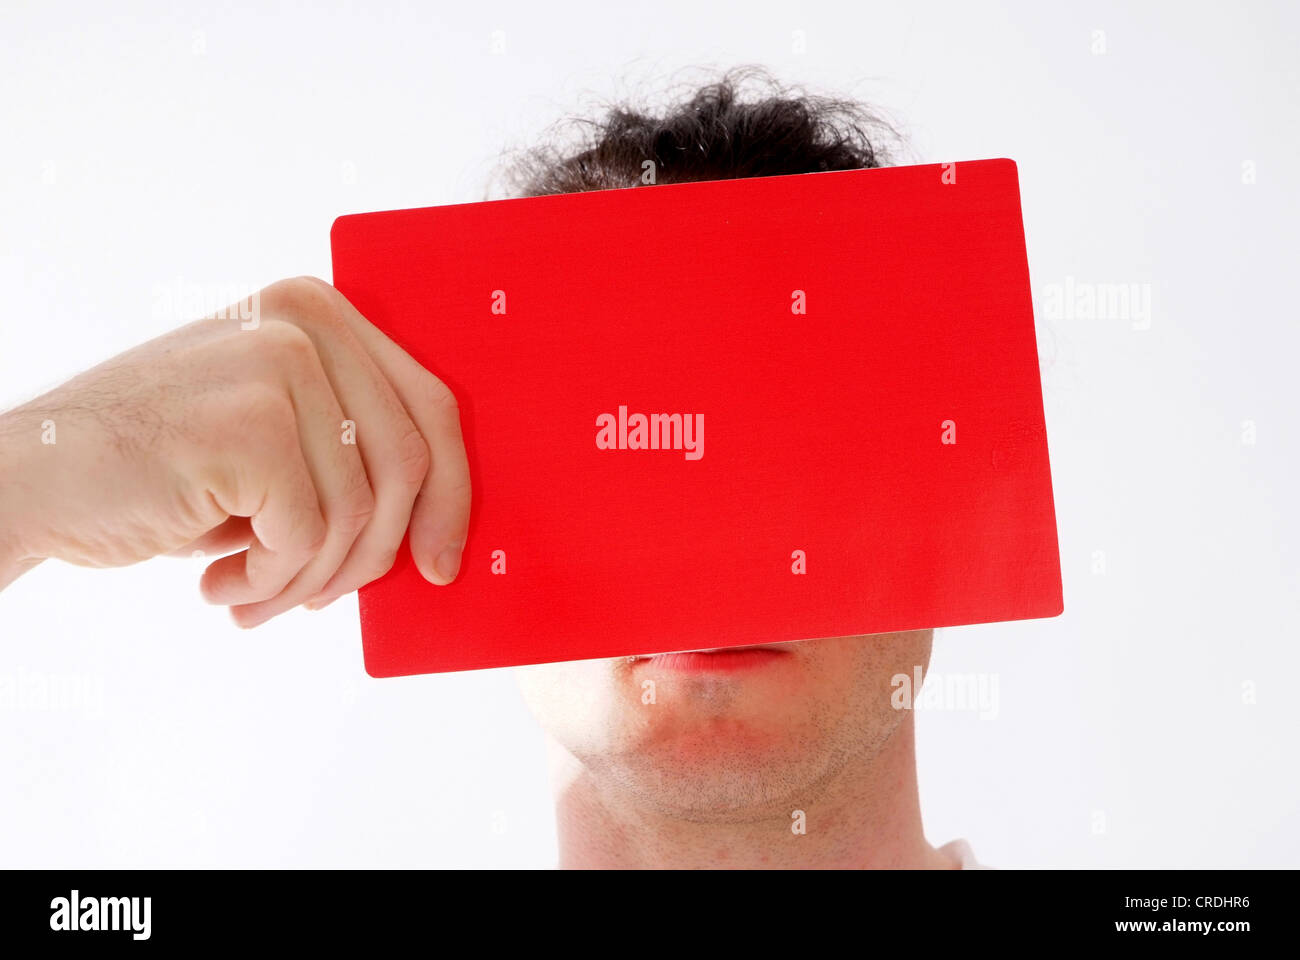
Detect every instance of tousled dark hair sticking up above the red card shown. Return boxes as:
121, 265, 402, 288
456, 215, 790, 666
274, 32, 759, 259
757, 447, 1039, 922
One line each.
504, 68, 897, 196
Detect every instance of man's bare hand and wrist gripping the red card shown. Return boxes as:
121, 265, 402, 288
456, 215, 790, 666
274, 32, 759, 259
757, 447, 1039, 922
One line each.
0, 278, 469, 627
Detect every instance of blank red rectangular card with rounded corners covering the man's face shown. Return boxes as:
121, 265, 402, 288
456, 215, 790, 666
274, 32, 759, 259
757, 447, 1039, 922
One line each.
332, 160, 1062, 676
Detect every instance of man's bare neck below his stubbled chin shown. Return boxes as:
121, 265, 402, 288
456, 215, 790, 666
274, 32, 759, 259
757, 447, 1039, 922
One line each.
551, 714, 956, 869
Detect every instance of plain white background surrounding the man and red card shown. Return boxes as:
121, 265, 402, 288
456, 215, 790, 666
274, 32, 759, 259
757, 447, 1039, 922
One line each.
0, 0, 1300, 866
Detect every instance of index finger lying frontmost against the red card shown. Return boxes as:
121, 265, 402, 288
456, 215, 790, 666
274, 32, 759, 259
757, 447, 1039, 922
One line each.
325, 283, 471, 584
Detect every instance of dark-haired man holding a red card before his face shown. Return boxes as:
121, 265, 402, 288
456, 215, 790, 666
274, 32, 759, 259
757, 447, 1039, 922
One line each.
0, 74, 974, 868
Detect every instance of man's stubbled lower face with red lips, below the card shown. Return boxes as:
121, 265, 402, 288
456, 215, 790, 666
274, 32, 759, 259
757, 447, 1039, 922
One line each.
519, 630, 933, 820
